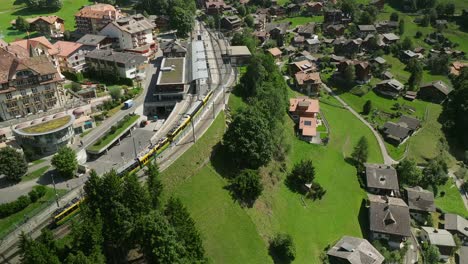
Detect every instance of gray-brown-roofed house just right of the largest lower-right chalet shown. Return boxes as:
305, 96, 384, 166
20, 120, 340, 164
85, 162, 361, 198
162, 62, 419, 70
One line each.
405, 186, 435, 221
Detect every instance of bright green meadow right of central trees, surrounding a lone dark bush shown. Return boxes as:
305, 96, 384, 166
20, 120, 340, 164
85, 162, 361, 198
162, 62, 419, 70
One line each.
243, 92, 382, 263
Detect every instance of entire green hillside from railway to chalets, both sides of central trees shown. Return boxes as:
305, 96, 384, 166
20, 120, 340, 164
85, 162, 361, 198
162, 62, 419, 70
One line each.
162, 86, 382, 263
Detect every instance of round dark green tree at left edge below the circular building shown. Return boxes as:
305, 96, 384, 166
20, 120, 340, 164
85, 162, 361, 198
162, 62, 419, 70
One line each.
0, 147, 28, 181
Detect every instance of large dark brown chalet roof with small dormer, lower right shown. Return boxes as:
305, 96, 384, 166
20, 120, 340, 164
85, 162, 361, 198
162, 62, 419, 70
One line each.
367, 194, 411, 237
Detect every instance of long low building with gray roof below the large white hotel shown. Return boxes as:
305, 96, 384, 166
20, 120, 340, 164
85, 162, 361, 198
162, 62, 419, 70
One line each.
85, 50, 146, 79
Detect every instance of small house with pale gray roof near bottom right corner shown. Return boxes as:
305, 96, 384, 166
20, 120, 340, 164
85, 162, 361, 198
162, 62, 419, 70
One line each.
421, 226, 456, 262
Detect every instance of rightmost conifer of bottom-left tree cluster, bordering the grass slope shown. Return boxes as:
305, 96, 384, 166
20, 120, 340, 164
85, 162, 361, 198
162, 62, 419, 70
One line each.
164, 197, 205, 263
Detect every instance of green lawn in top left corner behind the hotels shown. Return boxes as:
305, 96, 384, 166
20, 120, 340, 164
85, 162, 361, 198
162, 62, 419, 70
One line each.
0, 0, 92, 41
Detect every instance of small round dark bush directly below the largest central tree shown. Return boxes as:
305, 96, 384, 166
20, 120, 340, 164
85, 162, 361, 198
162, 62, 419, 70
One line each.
230, 169, 263, 204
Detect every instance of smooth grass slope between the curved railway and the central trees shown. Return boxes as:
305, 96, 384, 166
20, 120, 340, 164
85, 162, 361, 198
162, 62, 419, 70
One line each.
162, 115, 271, 263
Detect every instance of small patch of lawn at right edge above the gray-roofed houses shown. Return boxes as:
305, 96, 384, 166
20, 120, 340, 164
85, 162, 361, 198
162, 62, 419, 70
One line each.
435, 178, 468, 217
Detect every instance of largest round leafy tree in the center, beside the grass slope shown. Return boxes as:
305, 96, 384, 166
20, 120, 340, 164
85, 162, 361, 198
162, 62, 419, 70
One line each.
223, 108, 273, 169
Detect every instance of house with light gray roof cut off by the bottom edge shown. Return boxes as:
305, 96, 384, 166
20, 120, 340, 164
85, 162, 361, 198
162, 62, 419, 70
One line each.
327, 236, 384, 264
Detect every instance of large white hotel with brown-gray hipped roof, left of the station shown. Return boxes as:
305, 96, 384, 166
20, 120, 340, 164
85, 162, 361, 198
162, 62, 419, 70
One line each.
100, 14, 156, 57
